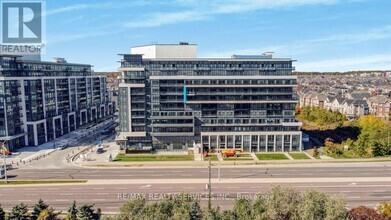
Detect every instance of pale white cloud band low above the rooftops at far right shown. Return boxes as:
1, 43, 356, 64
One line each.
296, 54, 391, 71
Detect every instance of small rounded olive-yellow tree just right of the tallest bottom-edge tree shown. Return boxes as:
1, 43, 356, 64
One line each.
298, 190, 328, 220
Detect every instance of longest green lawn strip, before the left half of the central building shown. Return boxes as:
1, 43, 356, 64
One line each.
114, 154, 194, 162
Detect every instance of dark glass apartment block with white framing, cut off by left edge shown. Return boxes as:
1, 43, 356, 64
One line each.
0, 54, 114, 150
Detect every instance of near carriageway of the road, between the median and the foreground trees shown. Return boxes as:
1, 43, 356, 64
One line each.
0, 182, 391, 212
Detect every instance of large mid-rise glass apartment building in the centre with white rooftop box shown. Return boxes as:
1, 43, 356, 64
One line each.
117, 43, 302, 152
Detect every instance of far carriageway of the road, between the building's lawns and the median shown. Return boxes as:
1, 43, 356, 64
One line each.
8, 162, 391, 180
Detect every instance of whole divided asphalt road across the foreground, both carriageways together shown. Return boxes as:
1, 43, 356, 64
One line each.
0, 149, 391, 212
